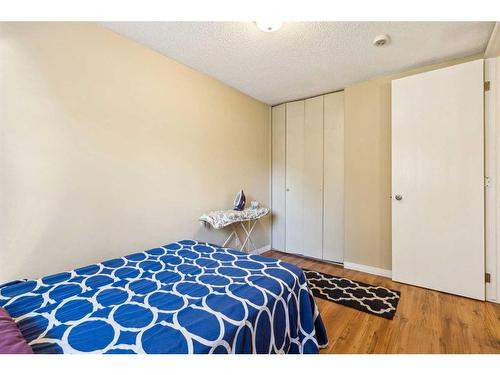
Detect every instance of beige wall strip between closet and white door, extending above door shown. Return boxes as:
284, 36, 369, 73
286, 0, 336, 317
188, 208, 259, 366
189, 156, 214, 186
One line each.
344, 56, 482, 269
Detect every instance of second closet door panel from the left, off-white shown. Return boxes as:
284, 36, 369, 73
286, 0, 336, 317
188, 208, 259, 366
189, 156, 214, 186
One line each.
286, 101, 304, 254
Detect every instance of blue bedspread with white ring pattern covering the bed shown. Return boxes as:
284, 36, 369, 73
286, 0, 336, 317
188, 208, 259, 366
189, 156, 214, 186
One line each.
0, 240, 328, 353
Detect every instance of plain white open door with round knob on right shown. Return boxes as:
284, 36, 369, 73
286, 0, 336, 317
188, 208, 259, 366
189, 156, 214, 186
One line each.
392, 60, 485, 300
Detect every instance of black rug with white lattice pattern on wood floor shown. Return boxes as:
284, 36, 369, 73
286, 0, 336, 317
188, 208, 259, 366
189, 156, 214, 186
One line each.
304, 269, 401, 320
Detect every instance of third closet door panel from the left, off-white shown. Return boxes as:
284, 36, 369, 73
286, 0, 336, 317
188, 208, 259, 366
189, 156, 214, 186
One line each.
302, 96, 323, 258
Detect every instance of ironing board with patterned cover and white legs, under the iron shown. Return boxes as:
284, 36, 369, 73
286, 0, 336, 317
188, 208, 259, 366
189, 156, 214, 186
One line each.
199, 207, 271, 252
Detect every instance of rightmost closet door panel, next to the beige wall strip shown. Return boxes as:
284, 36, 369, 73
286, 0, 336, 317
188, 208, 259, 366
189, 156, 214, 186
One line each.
323, 91, 344, 263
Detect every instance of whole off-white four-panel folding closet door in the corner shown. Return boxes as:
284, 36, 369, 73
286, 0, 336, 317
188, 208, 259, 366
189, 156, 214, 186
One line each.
271, 90, 344, 263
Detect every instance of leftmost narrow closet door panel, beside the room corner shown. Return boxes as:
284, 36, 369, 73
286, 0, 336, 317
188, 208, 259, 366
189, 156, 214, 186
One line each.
271, 104, 286, 251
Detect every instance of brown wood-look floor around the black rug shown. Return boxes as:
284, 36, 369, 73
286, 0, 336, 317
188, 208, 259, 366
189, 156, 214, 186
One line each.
263, 251, 500, 354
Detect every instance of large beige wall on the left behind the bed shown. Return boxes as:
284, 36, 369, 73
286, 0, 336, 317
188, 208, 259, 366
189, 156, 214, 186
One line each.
0, 23, 270, 281
